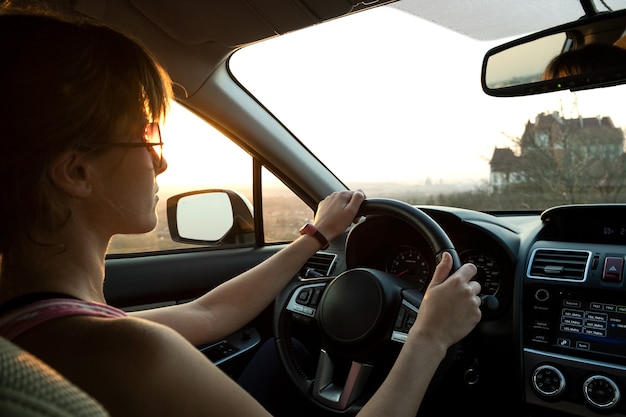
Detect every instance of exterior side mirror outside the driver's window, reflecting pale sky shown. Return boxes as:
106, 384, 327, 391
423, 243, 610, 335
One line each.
167, 190, 255, 246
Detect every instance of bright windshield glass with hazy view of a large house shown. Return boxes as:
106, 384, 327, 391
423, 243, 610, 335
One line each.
231, 7, 626, 211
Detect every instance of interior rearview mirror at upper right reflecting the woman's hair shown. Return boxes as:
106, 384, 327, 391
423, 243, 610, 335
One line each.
481, 11, 626, 97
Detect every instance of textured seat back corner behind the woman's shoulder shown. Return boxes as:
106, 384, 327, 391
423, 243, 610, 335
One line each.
0, 338, 109, 417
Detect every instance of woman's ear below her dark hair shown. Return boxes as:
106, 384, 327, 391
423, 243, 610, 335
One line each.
48, 151, 91, 198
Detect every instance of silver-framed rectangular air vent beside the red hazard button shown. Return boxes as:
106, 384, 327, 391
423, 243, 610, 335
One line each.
528, 249, 591, 281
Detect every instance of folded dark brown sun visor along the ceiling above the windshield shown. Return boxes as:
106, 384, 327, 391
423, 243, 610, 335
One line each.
74, 0, 394, 48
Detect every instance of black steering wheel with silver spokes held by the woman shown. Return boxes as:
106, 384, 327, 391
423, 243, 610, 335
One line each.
274, 199, 461, 413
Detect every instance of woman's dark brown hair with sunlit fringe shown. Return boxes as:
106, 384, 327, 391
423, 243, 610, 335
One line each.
0, 12, 172, 256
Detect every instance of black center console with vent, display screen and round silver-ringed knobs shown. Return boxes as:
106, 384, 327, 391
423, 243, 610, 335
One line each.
522, 241, 626, 416
